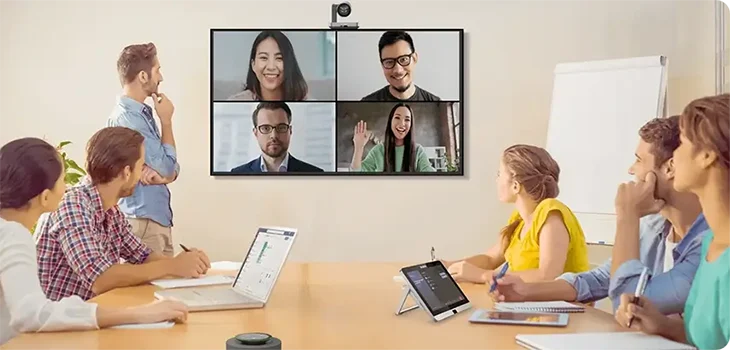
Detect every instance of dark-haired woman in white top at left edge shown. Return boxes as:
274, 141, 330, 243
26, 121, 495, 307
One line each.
0, 138, 187, 345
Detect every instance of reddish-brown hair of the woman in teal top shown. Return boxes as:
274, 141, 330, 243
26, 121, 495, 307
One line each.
679, 94, 730, 168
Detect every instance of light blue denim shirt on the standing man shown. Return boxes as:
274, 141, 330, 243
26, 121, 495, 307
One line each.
107, 96, 180, 227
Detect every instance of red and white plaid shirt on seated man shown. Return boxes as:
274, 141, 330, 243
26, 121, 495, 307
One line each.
36, 177, 151, 301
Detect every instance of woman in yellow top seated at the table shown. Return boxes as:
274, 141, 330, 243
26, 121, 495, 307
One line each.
444, 145, 590, 283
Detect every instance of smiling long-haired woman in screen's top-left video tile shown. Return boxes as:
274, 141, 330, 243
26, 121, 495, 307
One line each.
228, 30, 309, 101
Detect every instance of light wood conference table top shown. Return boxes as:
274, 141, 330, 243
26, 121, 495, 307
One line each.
2, 262, 622, 350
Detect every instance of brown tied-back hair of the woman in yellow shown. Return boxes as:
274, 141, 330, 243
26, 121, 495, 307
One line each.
500, 145, 560, 251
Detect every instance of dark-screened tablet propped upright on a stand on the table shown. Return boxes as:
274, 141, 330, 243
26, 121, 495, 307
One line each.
402, 261, 469, 316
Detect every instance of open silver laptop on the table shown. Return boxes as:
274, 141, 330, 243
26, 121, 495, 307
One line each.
155, 227, 297, 312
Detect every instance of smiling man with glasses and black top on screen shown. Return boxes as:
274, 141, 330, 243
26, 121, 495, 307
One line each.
362, 31, 441, 101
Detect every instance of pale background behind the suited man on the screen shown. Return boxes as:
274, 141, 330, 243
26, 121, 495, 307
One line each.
213, 102, 335, 172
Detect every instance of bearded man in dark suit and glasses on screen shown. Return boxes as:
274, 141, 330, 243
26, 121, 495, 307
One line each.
231, 102, 324, 174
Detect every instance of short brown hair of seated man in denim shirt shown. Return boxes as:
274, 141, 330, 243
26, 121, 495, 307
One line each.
639, 115, 679, 167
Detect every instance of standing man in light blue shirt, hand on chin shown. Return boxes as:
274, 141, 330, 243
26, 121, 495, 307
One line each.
107, 43, 180, 256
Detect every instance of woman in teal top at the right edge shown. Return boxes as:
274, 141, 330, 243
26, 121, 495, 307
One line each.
616, 94, 730, 350
